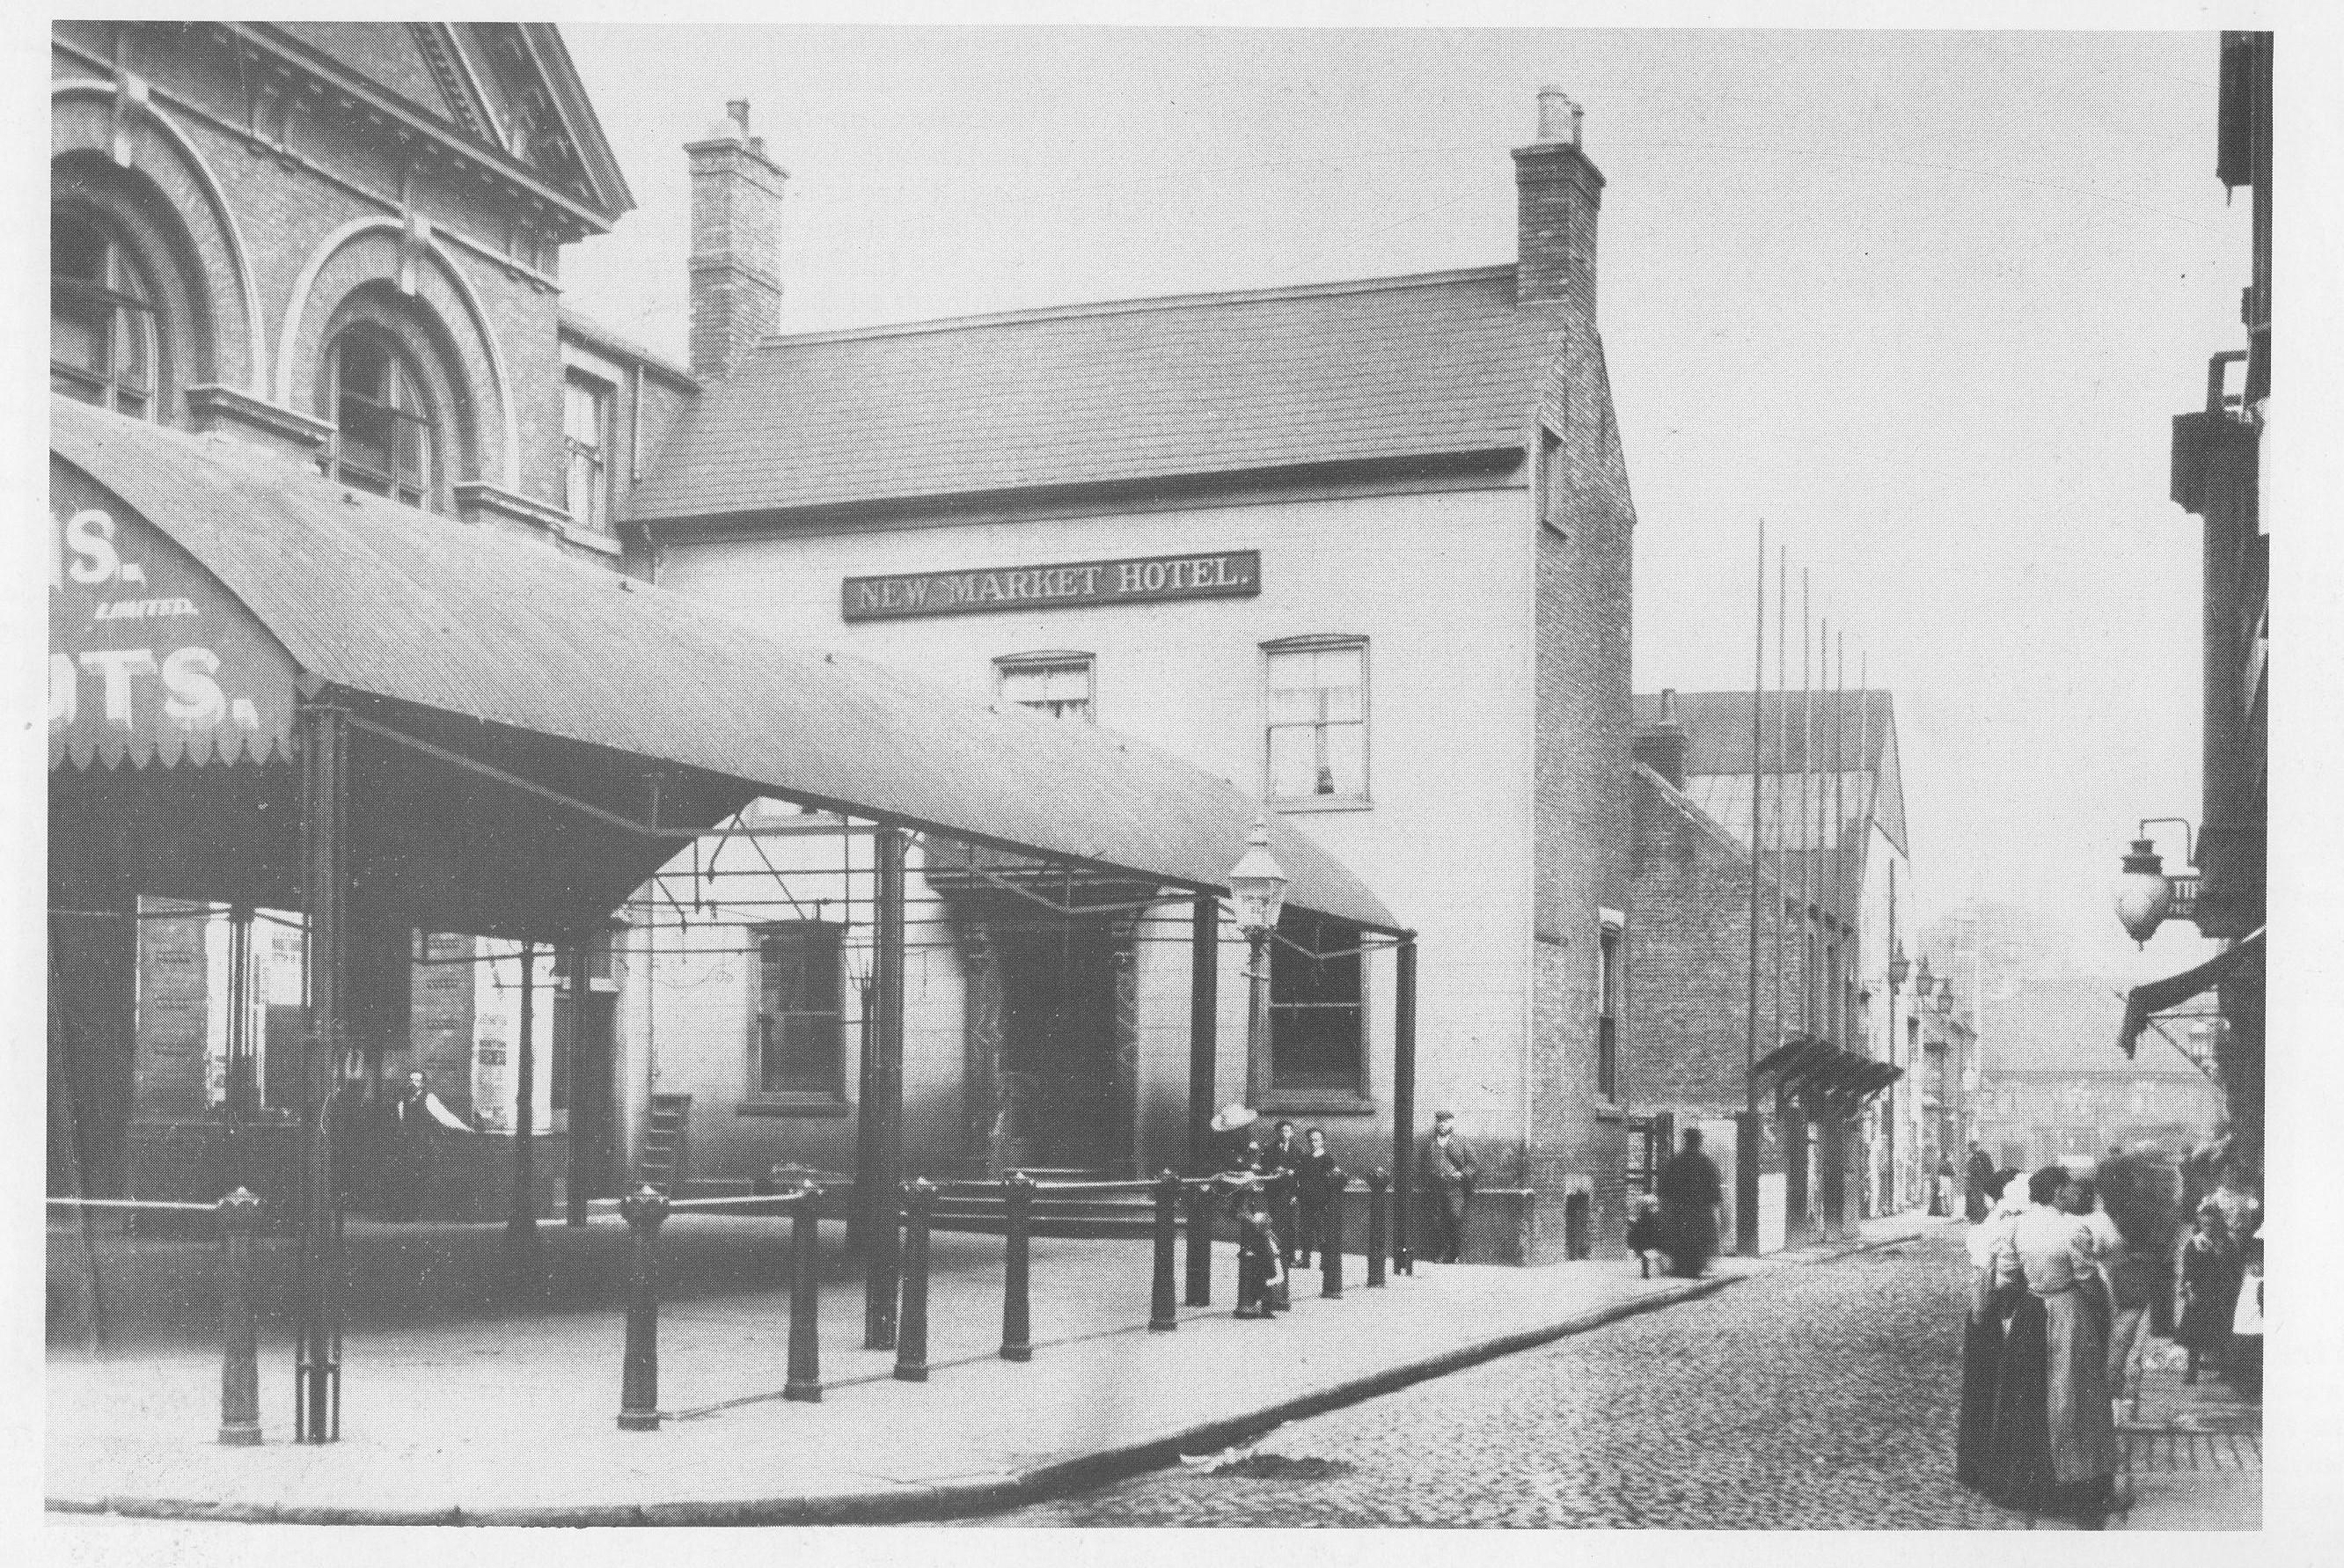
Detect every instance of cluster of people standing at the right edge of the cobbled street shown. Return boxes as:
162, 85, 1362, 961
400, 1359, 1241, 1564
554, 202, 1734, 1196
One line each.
1955, 1148, 2268, 1530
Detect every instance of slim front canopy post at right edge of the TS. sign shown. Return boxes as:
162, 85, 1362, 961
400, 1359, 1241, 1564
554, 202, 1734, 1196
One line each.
293, 703, 349, 1444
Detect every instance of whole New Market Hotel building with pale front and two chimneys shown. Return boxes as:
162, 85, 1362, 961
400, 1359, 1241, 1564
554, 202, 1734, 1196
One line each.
626, 92, 1634, 1258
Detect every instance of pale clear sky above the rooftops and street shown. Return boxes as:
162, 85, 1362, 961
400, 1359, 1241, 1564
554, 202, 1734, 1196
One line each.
562, 24, 2248, 985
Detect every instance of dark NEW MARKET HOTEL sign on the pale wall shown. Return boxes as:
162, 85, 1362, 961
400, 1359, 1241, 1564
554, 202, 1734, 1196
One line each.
839, 551, 1261, 621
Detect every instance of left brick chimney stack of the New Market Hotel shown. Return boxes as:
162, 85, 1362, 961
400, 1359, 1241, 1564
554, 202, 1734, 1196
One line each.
685, 99, 790, 382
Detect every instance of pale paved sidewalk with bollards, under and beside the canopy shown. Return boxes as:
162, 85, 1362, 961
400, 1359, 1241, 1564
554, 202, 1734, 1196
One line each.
45, 1216, 1945, 1526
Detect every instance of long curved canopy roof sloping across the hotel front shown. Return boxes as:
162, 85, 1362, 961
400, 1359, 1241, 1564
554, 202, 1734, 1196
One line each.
49, 396, 1399, 933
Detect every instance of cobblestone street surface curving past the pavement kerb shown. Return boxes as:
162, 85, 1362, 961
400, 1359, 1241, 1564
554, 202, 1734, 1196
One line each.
968, 1230, 2222, 1528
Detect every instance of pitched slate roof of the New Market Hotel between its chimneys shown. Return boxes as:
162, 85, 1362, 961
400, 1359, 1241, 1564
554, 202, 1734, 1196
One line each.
635, 265, 1557, 520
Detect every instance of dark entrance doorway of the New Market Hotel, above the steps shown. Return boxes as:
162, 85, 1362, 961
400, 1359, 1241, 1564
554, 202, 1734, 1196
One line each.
999, 921, 1127, 1169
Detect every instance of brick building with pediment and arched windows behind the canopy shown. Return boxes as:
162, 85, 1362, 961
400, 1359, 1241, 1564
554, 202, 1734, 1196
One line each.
49, 21, 696, 1195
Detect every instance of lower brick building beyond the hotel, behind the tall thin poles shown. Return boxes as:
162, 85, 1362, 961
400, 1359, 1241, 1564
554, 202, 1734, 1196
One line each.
1631, 692, 1922, 1249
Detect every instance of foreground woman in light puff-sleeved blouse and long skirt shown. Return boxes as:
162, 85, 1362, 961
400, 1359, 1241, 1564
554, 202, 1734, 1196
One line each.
1990, 1165, 2117, 1530
